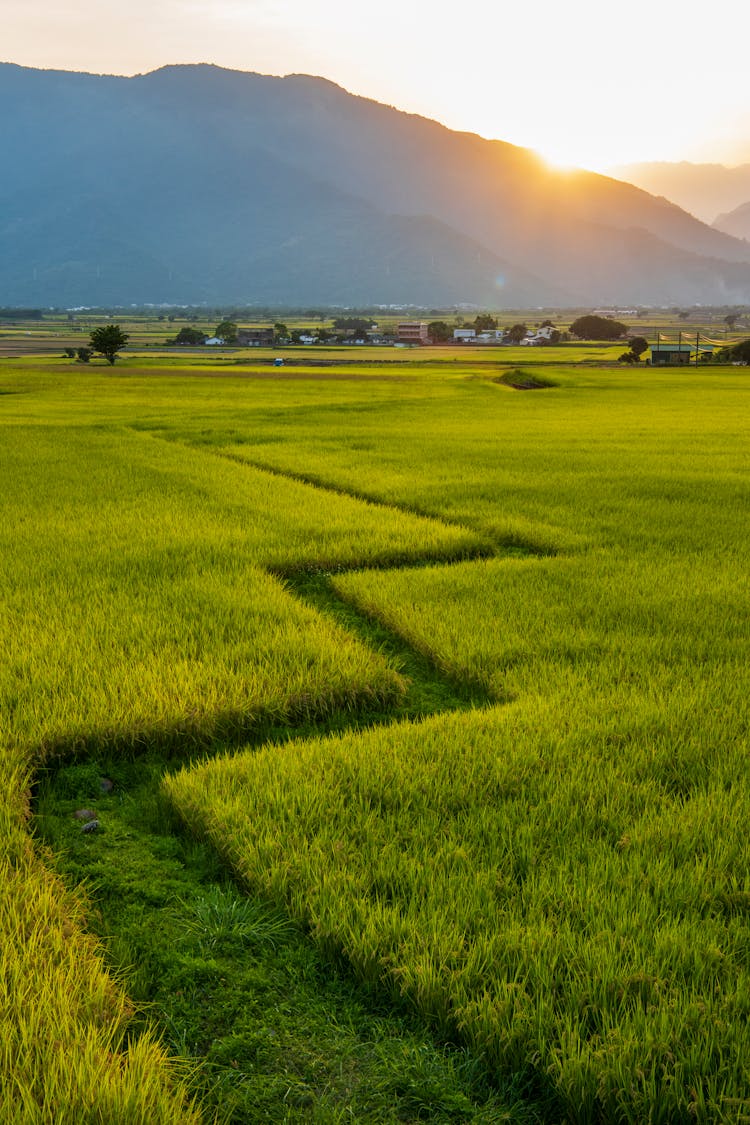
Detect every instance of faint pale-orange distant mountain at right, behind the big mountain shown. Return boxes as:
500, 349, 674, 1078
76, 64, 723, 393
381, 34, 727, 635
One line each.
612, 161, 750, 226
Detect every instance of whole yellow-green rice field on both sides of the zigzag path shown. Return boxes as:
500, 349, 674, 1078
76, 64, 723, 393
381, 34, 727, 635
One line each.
0, 360, 750, 1123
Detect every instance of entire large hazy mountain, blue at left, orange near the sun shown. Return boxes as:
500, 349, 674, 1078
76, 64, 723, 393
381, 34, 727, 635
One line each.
0, 64, 750, 307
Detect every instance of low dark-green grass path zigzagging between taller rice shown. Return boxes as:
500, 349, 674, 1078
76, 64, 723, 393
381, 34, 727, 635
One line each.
30, 558, 528, 1125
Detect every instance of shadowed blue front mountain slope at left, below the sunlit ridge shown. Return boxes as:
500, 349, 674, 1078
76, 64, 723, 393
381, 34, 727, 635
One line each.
0, 66, 579, 305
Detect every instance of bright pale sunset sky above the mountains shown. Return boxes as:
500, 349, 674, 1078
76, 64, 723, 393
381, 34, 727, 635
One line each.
5, 0, 750, 171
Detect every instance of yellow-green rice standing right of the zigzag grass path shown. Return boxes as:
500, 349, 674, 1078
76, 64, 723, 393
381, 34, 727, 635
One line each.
158, 371, 750, 1125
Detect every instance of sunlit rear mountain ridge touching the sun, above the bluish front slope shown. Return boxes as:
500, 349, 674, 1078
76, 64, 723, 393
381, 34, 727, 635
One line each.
132, 66, 750, 276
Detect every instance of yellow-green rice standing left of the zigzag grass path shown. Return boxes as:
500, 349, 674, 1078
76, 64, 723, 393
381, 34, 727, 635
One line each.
0, 369, 482, 1125
